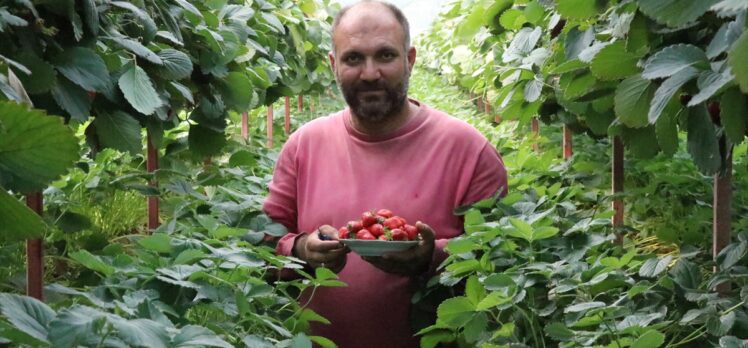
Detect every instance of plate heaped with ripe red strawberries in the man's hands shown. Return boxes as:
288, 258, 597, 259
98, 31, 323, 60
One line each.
338, 209, 420, 256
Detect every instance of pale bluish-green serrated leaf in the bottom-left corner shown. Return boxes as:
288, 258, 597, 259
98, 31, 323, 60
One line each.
0, 292, 55, 343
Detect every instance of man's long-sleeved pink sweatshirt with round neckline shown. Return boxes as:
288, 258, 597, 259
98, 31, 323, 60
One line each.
264, 101, 507, 348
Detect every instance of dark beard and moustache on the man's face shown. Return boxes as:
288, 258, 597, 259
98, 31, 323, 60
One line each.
336, 71, 410, 123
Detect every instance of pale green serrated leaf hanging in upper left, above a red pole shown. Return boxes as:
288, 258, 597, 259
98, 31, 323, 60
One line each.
119, 65, 162, 115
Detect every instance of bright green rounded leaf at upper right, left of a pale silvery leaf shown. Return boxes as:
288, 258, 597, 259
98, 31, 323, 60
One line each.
590, 41, 641, 81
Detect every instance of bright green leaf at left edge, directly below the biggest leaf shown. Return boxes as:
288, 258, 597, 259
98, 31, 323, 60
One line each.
0, 188, 46, 242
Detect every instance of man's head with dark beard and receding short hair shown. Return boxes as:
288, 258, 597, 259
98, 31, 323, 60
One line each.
330, 5, 415, 122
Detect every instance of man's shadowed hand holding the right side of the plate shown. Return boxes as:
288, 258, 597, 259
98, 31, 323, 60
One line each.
363, 221, 435, 276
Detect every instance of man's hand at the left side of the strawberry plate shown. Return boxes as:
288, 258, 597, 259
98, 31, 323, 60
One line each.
294, 225, 350, 273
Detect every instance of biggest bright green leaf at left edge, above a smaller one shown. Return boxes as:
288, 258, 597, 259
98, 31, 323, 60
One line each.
0, 102, 78, 191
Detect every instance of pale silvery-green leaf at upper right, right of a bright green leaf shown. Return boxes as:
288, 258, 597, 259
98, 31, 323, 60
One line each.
642, 44, 708, 80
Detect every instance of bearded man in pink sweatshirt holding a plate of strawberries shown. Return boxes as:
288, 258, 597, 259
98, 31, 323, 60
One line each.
264, 1, 506, 348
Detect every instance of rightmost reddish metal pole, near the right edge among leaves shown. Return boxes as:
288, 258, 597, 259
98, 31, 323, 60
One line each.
712, 150, 732, 294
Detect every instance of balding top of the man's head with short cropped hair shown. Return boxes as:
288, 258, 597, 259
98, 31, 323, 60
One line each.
332, 0, 410, 54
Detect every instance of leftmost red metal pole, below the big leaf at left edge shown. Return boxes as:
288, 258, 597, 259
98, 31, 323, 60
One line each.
26, 192, 44, 301
